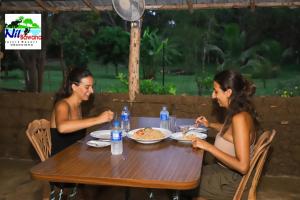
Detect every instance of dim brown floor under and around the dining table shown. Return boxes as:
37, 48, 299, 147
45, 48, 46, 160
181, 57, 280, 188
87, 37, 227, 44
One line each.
0, 158, 300, 200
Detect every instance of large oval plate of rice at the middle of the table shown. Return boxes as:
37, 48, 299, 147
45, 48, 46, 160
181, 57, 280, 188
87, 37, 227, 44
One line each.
127, 128, 171, 144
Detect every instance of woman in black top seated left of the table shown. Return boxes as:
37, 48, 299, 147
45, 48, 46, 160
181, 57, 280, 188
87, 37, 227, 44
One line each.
50, 67, 114, 155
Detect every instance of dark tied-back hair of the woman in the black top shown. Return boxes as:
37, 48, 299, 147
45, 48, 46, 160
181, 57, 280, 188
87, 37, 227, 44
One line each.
54, 67, 93, 104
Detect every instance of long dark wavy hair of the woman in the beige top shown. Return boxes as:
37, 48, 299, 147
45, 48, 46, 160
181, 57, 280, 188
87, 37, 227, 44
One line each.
214, 70, 260, 134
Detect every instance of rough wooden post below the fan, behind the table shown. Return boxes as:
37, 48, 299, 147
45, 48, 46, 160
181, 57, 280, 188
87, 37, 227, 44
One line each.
128, 20, 142, 102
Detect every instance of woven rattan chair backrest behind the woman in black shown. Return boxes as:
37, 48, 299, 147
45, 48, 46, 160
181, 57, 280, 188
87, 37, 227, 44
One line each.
26, 119, 52, 161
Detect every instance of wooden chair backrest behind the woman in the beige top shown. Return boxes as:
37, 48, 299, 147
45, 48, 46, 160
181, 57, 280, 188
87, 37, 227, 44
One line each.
233, 130, 276, 200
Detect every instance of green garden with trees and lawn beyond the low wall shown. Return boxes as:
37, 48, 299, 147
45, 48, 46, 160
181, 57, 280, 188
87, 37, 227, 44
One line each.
0, 8, 300, 97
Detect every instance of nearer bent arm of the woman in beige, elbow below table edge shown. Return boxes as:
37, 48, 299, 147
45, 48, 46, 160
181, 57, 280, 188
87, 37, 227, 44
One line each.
193, 112, 251, 174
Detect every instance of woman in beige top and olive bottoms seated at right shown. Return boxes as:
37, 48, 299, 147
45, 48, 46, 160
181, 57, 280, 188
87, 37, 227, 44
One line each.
193, 70, 260, 200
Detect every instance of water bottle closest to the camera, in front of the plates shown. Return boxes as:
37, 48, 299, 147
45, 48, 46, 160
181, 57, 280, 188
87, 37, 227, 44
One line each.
110, 120, 123, 155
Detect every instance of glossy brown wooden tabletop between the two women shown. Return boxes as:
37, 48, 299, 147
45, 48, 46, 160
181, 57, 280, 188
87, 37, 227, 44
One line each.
30, 117, 203, 194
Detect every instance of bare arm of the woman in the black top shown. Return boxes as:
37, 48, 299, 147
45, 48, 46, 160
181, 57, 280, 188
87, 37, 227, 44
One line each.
54, 101, 114, 133
